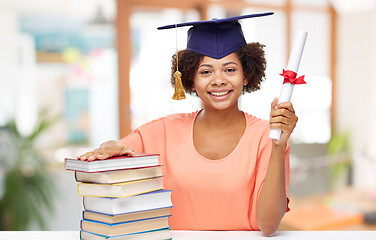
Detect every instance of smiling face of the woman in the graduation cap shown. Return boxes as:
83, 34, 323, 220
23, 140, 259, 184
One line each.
194, 53, 247, 110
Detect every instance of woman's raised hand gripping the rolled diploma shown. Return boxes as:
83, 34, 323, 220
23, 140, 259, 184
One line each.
269, 98, 298, 146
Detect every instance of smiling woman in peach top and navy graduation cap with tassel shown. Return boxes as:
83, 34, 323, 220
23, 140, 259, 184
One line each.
79, 13, 297, 235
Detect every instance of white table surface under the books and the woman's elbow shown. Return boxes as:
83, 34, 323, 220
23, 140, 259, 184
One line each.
0, 231, 376, 240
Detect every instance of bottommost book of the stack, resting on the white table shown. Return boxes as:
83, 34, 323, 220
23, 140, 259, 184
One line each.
80, 228, 172, 240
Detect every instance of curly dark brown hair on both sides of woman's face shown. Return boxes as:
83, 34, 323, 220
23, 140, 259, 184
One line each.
171, 42, 266, 94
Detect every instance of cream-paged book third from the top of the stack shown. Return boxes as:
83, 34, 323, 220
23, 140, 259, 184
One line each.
77, 177, 163, 197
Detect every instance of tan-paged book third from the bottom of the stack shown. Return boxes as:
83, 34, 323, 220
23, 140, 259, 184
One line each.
82, 207, 171, 224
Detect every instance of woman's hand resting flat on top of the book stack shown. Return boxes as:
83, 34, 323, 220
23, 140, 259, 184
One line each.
77, 140, 135, 162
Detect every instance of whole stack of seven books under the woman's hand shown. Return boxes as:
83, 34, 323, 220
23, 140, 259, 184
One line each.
65, 154, 172, 240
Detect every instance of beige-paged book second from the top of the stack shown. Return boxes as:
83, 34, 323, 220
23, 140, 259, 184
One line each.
75, 165, 163, 184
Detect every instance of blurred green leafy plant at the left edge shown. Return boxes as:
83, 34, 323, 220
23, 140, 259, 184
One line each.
0, 110, 57, 231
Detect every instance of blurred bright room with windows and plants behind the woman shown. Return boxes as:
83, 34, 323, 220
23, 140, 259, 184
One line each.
0, 0, 376, 230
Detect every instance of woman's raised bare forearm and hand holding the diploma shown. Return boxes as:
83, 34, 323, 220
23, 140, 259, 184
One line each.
256, 99, 298, 236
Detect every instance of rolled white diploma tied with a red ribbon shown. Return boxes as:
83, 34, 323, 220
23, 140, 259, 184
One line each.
269, 30, 308, 140
